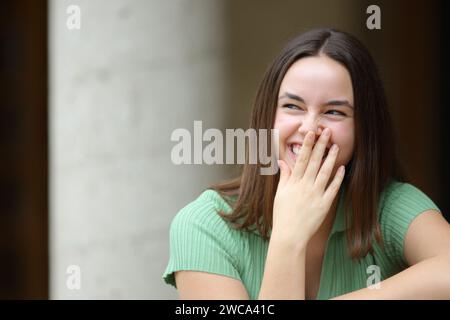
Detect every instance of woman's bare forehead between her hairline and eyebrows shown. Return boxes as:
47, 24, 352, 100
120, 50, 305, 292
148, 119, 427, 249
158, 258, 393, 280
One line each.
279, 56, 353, 102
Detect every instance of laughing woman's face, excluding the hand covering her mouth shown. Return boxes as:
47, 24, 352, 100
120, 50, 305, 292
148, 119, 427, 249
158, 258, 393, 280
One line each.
274, 56, 354, 175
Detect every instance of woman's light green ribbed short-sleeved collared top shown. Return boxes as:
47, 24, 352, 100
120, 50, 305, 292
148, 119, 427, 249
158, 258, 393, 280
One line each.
163, 181, 440, 299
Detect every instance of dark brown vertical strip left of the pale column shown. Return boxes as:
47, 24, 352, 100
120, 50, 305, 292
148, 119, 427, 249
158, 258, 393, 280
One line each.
0, 0, 48, 299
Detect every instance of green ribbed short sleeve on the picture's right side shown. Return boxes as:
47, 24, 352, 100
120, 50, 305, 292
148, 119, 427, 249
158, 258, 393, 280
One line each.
380, 181, 441, 267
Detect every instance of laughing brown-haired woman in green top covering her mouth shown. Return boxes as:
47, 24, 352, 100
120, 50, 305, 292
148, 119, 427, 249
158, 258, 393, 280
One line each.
163, 29, 450, 299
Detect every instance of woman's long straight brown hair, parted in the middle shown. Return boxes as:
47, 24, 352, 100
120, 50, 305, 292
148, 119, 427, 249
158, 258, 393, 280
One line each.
211, 28, 406, 258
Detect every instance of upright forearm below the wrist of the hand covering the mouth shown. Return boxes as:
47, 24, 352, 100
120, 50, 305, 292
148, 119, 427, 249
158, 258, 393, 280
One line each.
258, 235, 306, 300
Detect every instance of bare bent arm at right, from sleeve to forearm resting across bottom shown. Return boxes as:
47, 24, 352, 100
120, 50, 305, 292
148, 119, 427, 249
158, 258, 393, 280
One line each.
335, 210, 450, 299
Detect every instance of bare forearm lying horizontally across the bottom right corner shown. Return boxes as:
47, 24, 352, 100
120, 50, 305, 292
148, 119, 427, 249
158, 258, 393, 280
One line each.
334, 255, 450, 300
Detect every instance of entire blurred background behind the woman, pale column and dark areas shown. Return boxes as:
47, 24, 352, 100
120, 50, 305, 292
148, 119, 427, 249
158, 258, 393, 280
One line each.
0, 0, 450, 299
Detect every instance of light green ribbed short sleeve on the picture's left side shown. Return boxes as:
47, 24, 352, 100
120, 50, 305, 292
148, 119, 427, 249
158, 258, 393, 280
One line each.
163, 190, 241, 288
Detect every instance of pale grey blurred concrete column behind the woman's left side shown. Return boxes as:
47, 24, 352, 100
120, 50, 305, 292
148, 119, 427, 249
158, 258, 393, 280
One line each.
49, 0, 227, 299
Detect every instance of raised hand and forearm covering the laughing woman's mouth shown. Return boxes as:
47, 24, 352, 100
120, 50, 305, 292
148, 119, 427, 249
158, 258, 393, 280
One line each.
259, 131, 344, 299
